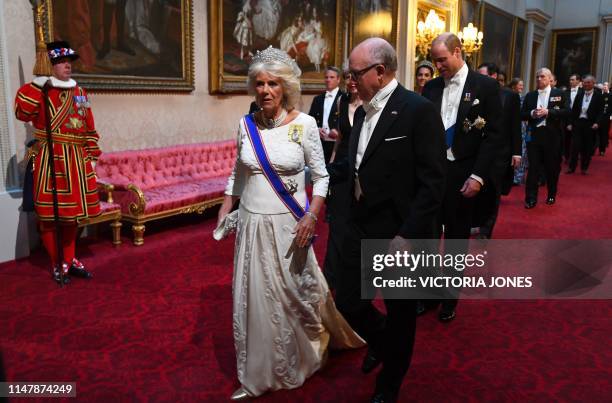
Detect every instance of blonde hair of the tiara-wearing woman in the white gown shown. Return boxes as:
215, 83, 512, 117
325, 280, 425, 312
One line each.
247, 60, 301, 111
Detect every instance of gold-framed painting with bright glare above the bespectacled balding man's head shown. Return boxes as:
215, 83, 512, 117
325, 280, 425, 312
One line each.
349, 0, 398, 49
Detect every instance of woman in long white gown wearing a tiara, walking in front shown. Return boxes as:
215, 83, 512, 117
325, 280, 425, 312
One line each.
219, 47, 364, 400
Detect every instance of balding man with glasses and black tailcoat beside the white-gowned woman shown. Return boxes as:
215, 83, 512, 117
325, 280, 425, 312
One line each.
336, 38, 446, 402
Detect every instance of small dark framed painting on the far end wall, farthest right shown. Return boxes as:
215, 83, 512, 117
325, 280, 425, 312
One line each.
551, 28, 598, 86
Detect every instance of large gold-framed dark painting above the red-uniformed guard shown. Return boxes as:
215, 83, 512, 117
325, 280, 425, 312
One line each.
44, 0, 194, 91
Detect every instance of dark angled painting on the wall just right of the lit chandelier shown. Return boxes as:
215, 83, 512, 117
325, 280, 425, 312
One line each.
478, 4, 514, 79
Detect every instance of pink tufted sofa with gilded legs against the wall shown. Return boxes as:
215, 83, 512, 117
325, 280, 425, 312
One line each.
96, 140, 236, 245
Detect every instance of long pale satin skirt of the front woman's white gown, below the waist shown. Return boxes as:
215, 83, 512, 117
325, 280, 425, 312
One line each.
233, 208, 364, 396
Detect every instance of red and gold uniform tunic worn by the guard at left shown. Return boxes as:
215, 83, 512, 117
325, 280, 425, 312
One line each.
15, 77, 100, 223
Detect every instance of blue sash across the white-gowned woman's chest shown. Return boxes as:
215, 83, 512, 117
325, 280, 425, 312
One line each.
244, 114, 308, 221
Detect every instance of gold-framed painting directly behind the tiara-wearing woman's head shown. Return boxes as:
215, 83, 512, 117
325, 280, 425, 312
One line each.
208, 0, 342, 92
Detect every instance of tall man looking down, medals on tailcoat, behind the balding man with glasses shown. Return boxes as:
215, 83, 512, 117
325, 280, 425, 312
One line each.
423, 32, 504, 322
